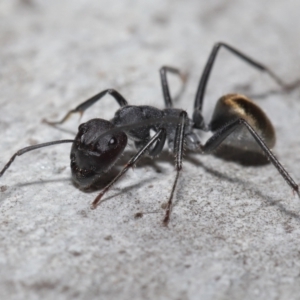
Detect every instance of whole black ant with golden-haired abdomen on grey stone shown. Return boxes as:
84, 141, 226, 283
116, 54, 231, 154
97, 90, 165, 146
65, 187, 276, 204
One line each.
0, 43, 300, 225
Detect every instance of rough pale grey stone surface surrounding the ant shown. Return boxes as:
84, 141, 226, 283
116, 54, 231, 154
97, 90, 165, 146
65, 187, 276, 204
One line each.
0, 0, 300, 300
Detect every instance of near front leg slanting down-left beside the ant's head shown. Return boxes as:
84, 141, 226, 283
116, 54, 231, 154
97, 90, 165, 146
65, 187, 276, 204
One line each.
91, 129, 166, 209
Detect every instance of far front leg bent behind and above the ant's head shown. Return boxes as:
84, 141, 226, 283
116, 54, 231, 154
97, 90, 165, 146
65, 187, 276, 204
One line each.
43, 89, 128, 126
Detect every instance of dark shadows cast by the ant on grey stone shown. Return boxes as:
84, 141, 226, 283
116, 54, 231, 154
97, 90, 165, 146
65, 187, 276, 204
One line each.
0, 145, 300, 221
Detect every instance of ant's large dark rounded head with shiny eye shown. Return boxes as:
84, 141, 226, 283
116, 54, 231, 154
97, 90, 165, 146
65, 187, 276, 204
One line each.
71, 119, 127, 188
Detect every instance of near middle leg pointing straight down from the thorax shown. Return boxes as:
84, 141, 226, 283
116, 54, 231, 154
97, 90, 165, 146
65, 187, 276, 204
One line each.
163, 111, 187, 226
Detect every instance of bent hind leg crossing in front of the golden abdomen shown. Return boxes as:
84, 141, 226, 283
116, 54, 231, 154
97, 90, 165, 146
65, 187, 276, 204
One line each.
201, 118, 300, 197
